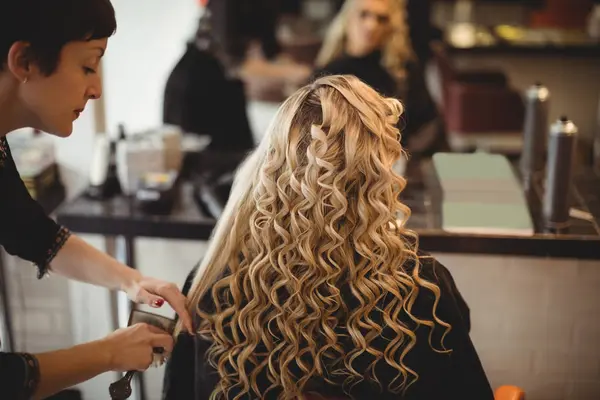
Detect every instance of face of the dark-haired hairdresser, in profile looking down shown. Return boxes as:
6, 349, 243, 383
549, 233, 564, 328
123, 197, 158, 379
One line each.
20, 39, 108, 137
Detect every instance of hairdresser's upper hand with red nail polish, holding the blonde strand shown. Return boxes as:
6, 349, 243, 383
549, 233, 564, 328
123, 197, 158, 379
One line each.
124, 277, 193, 333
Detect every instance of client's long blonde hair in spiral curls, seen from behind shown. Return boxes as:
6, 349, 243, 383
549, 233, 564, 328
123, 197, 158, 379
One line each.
183, 75, 450, 399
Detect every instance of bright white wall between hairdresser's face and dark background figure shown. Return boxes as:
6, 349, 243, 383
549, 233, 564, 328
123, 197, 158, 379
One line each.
103, 0, 200, 134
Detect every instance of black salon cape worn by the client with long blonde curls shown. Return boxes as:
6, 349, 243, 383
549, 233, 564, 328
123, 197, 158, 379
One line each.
163, 254, 494, 400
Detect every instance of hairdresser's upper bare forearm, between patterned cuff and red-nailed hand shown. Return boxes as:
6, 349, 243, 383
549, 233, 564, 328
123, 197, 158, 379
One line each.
51, 235, 141, 290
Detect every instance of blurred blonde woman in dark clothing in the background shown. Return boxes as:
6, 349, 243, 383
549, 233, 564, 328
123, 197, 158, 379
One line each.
313, 0, 436, 149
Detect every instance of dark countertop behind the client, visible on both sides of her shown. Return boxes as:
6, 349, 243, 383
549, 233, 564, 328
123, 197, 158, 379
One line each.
57, 163, 600, 259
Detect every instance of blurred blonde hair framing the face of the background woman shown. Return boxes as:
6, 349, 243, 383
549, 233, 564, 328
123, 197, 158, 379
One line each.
316, 0, 413, 80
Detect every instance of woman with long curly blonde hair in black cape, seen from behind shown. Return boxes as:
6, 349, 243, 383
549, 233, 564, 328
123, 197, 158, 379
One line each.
164, 76, 493, 400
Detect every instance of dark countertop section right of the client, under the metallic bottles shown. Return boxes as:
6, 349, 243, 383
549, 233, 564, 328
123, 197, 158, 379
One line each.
402, 162, 600, 259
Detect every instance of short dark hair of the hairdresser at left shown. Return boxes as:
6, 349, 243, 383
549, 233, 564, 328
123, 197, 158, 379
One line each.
0, 0, 117, 75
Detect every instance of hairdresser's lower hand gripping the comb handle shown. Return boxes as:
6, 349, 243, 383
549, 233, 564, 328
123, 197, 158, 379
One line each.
100, 324, 173, 372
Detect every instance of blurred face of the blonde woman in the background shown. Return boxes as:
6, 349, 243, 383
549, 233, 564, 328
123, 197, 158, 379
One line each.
346, 0, 390, 56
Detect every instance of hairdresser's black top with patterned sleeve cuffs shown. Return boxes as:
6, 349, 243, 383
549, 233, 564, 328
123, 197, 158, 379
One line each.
0, 137, 71, 400
